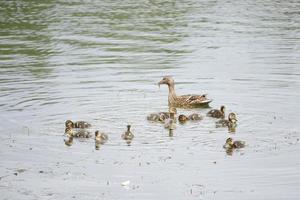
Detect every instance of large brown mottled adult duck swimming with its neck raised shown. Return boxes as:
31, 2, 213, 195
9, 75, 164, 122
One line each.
158, 76, 212, 108
